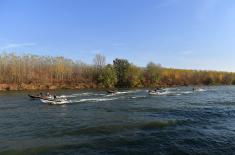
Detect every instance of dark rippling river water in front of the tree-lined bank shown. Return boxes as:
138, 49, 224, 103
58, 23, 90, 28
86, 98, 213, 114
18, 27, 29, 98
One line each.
0, 86, 235, 155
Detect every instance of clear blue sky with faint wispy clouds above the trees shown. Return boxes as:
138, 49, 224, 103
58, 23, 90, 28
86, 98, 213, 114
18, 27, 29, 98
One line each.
0, 0, 235, 71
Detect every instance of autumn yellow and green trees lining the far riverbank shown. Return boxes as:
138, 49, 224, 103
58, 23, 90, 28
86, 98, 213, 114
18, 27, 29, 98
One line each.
0, 53, 235, 91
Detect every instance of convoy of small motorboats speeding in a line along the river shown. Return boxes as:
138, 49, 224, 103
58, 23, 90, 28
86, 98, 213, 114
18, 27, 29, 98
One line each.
28, 88, 203, 105
